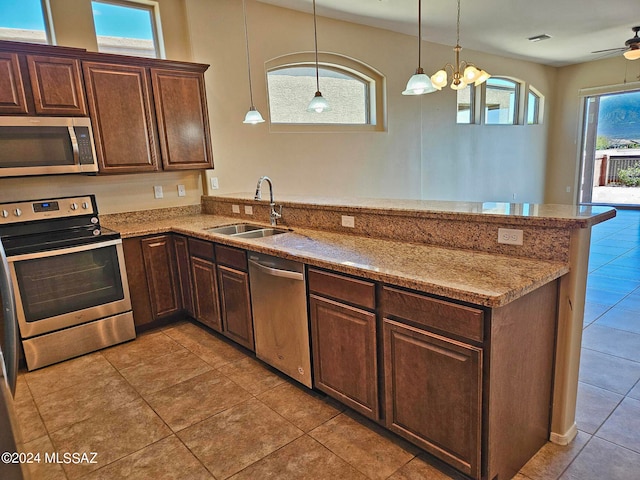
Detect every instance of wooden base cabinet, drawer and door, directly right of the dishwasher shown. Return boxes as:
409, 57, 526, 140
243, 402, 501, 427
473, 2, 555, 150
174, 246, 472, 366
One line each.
308, 268, 380, 420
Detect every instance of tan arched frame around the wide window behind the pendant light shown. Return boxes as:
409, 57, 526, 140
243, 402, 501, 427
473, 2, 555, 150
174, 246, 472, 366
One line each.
264, 52, 387, 133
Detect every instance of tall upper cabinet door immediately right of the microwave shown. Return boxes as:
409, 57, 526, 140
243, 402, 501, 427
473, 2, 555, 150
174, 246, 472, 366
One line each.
83, 62, 158, 173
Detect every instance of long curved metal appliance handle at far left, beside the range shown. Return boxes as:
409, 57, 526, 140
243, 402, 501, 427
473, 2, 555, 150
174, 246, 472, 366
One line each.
0, 242, 20, 395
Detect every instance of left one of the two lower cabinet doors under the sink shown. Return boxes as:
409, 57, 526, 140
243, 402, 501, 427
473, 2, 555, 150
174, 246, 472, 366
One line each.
191, 256, 222, 332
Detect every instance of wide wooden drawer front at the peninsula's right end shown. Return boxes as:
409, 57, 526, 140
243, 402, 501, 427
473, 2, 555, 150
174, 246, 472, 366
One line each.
382, 287, 484, 342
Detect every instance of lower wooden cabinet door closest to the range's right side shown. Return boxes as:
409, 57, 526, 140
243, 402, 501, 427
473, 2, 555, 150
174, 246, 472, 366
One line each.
142, 235, 181, 320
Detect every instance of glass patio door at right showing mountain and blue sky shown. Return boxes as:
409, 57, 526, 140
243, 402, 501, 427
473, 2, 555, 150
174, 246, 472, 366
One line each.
580, 90, 640, 207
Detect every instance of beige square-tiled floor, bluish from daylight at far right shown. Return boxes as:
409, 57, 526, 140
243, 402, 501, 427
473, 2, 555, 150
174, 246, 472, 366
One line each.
16, 213, 640, 480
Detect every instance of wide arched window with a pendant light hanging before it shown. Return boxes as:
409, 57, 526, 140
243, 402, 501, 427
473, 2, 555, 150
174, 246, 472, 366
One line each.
267, 53, 384, 131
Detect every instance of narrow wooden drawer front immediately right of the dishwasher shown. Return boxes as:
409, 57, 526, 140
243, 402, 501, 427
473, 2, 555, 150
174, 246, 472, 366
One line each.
308, 268, 376, 310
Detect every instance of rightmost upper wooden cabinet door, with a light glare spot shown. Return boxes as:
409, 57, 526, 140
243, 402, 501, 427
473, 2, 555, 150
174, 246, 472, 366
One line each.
151, 68, 213, 170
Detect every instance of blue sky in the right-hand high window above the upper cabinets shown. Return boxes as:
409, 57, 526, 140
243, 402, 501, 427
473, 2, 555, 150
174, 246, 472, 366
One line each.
92, 0, 153, 40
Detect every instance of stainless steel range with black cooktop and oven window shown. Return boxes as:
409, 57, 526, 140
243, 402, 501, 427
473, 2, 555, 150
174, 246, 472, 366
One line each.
0, 195, 135, 370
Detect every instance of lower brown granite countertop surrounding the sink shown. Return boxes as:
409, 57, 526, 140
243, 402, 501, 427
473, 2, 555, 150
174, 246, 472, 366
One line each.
102, 214, 569, 307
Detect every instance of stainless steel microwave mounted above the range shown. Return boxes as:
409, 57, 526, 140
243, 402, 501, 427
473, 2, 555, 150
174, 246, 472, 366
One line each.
0, 116, 98, 177
